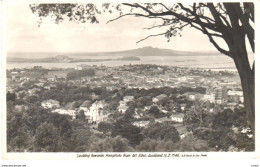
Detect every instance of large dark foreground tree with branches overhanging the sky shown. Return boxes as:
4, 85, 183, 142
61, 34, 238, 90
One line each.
30, 2, 255, 131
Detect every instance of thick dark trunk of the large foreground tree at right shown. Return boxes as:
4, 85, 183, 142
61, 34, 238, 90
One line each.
230, 37, 255, 136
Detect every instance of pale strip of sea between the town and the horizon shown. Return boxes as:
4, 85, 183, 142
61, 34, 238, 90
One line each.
6, 53, 254, 71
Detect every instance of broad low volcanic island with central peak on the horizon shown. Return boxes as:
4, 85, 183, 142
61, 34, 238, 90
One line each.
67, 46, 220, 57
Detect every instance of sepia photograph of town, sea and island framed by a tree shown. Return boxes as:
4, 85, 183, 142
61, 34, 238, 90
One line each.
1, 1, 259, 158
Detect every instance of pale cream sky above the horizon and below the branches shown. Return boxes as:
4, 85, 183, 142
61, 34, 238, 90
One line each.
6, 3, 228, 52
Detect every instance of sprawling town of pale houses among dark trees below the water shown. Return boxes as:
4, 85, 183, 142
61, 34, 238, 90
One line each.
7, 63, 253, 152
